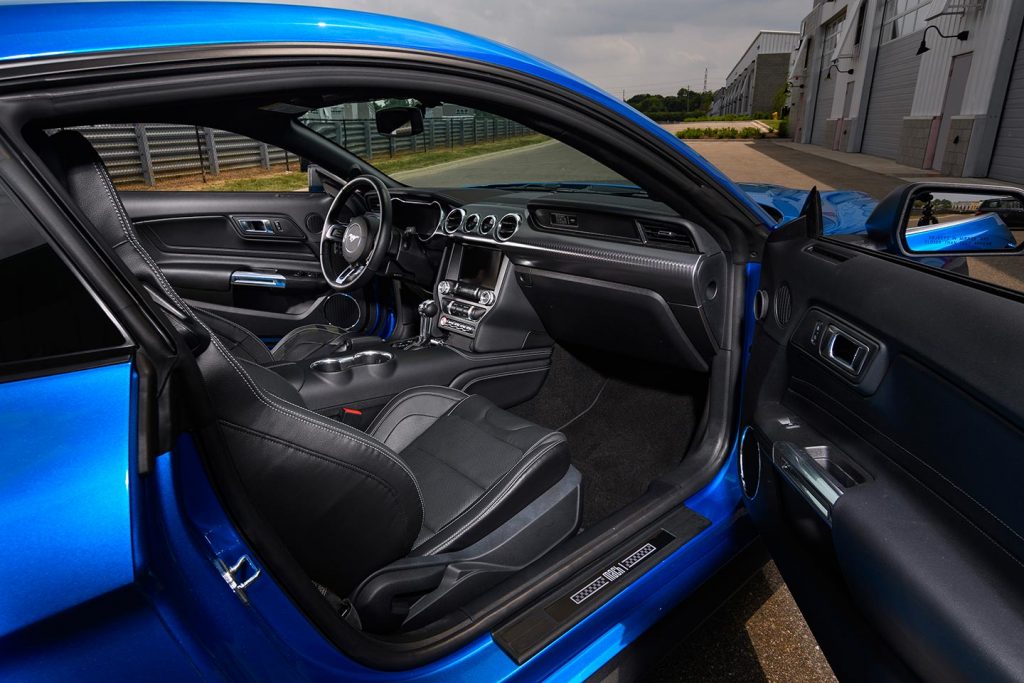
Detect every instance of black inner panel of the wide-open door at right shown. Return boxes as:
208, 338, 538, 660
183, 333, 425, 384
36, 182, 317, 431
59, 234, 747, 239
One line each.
739, 193, 1024, 681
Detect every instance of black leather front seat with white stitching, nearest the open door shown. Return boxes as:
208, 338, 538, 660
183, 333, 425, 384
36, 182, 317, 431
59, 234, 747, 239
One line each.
51, 132, 580, 630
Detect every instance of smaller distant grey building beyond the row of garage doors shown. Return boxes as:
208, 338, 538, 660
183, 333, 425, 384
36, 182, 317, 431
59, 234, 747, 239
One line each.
712, 31, 800, 116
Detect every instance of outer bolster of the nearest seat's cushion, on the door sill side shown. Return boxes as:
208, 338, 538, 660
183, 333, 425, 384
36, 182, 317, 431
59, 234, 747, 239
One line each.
413, 432, 571, 555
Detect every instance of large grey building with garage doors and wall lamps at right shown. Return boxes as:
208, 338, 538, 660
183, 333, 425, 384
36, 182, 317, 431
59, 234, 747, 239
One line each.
790, 0, 1024, 182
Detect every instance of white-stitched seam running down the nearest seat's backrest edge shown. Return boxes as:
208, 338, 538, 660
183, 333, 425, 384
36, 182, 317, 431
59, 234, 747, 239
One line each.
92, 162, 423, 509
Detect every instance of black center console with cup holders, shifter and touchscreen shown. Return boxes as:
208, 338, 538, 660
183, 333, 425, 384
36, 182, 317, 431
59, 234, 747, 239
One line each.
274, 243, 552, 428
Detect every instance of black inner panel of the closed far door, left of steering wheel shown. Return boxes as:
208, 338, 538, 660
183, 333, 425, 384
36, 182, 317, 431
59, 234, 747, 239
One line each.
122, 191, 337, 340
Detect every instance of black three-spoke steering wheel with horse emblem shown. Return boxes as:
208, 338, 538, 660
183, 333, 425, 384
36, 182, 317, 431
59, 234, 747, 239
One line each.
319, 175, 391, 292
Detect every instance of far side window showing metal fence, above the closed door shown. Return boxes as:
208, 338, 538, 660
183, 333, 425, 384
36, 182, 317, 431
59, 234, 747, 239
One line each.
68, 123, 309, 193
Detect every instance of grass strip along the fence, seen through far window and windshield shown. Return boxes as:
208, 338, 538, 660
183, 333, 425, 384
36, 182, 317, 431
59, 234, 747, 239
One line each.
171, 135, 549, 193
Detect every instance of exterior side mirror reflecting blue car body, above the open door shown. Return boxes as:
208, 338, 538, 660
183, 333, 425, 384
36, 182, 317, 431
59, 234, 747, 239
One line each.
867, 183, 1024, 256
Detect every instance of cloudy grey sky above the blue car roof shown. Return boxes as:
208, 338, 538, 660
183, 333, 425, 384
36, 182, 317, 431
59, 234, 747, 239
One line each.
262, 0, 813, 97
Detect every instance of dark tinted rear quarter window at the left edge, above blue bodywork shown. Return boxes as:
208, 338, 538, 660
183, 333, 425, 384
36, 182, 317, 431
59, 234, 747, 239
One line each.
0, 185, 125, 370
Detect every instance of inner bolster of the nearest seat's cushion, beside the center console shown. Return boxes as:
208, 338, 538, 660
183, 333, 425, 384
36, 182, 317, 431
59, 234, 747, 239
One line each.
367, 386, 469, 453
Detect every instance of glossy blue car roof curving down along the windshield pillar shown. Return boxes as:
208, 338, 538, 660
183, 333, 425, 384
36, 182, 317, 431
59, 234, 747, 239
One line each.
0, 2, 774, 225
